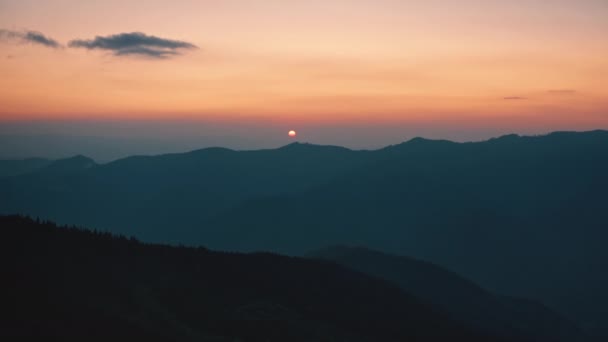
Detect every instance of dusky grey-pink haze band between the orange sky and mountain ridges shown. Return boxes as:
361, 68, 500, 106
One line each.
0, 120, 604, 162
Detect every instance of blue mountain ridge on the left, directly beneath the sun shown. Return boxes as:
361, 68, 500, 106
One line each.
0, 143, 367, 242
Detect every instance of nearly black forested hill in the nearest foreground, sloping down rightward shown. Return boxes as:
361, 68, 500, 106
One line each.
0, 216, 504, 341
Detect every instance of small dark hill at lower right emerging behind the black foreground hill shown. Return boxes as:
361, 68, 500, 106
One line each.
307, 246, 587, 342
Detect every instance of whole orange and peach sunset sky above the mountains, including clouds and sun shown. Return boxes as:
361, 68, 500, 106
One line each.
0, 0, 608, 158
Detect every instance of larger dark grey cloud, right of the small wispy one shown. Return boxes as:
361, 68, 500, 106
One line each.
68, 32, 198, 58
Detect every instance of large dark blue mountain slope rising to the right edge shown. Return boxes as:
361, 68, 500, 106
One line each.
205, 131, 608, 336
